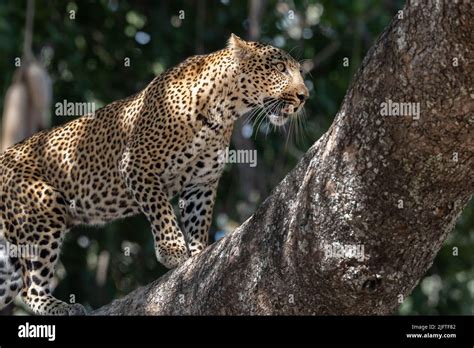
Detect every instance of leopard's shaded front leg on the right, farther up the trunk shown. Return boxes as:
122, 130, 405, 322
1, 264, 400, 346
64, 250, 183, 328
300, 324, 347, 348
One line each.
180, 180, 218, 256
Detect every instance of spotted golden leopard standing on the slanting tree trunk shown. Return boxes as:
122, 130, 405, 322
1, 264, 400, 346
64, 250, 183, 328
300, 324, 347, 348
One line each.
0, 34, 309, 315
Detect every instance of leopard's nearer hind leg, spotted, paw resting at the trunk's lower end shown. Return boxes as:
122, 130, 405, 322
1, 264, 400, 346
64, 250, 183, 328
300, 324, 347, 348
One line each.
5, 178, 85, 315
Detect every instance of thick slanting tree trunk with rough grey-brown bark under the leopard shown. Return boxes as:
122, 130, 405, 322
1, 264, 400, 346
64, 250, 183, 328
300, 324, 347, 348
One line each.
94, 0, 474, 315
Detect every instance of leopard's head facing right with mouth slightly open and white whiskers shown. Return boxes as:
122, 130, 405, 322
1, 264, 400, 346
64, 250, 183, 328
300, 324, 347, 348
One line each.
228, 34, 309, 126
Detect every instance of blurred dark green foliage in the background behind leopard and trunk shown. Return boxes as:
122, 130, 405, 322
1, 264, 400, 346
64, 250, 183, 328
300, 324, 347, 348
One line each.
0, 0, 474, 314
